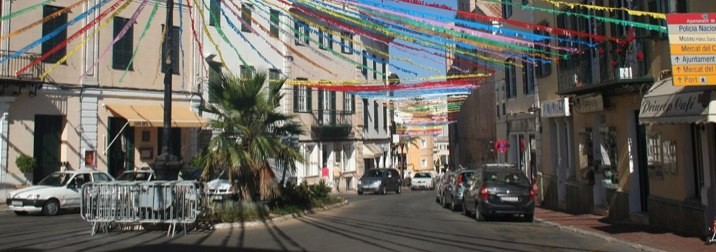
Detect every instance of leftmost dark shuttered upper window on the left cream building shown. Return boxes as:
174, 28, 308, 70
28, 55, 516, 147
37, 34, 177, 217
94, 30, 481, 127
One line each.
42, 5, 67, 63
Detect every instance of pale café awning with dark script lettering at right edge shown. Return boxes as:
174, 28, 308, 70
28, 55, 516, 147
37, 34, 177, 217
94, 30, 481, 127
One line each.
639, 77, 716, 124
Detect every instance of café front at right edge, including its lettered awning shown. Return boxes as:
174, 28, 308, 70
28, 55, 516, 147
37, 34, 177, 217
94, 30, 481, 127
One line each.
639, 78, 716, 234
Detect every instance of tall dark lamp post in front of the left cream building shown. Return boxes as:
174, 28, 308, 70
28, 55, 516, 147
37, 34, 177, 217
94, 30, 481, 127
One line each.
154, 0, 181, 180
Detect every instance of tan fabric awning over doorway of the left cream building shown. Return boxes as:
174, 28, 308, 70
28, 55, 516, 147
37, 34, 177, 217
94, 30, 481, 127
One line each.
105, 104, 207, 128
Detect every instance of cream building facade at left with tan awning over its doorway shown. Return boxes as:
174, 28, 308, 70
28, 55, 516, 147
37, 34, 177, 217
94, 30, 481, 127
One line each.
0, 0, 206, 202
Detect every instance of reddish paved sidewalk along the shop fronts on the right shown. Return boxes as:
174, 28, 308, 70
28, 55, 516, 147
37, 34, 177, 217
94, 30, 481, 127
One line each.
535, 207, 716, 252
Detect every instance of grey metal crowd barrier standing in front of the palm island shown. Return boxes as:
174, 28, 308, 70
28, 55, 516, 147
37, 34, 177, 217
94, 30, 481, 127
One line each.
80, 181, 202, 236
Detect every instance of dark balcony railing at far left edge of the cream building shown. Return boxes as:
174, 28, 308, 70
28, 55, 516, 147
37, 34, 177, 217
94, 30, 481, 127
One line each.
0, 50, 45, 81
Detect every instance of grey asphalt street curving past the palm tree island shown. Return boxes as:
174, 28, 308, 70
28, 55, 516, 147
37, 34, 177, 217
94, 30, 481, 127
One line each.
0, 190, 635, 252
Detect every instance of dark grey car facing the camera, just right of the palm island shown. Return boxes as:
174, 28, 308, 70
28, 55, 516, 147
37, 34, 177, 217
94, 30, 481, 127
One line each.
358, 169, 402, 194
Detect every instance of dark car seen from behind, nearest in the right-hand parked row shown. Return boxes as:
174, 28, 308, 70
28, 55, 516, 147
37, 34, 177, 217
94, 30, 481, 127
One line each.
463, 164, 536, 222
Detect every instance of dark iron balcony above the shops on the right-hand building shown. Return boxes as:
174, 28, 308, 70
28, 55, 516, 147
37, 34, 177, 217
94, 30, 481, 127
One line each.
557, 40, 654, 95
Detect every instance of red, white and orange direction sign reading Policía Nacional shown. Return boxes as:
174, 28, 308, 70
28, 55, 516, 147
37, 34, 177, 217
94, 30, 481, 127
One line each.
666, 13, 716, 86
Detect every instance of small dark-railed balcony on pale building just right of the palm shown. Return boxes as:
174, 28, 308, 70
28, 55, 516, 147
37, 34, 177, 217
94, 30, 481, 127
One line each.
311, 110, 353, 140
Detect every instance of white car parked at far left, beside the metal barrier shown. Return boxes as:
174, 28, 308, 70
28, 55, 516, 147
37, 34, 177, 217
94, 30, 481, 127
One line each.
7, 169, 114, 216
